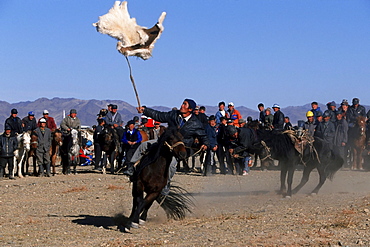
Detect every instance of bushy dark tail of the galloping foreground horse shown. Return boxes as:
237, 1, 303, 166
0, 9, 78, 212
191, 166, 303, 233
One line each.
156, 185, 195, 220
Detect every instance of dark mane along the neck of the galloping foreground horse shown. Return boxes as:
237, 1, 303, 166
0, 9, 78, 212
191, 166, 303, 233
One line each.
140, 128, 177, 170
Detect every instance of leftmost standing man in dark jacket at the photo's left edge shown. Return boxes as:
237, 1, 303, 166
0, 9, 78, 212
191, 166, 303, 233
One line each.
0, 125, 18, 180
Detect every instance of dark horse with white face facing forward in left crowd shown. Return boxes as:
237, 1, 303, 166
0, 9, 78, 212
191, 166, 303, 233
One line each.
60, 129, 81, 175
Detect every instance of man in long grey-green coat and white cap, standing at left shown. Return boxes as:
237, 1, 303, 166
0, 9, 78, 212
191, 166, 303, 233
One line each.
34, 118, 51, 177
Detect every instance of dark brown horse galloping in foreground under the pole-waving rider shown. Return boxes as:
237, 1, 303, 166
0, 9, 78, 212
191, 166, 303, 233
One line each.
119, 129, 193, 231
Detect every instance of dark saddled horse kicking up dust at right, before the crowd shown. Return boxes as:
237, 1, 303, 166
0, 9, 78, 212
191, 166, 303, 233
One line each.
260, 129, 343, 198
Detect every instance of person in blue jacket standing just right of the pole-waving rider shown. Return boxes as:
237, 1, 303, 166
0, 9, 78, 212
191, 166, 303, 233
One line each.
203, 115, 218, 176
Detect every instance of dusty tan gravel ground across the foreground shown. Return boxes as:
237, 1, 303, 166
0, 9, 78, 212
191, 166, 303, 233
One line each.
0, 167, 370, 246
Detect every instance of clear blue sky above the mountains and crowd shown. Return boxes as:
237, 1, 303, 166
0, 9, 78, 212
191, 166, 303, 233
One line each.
0, 0, 370, 108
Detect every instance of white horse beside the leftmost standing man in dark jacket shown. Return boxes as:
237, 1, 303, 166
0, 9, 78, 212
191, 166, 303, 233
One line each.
12, 132, 31, 178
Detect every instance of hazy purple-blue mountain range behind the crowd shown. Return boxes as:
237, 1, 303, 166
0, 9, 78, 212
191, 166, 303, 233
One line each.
0, 98, 369, 132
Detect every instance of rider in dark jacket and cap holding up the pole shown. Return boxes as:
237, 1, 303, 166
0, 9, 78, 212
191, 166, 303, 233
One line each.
124, 99, 209, 193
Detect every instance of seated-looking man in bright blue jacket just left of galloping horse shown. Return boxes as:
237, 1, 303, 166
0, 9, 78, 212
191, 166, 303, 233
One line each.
122, 120, 142, 176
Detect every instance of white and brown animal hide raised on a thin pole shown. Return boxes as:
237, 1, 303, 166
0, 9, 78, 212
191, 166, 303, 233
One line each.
93, 1, 166, 107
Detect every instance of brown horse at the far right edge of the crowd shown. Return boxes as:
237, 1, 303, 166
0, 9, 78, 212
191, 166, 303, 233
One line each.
348, 116, 366, 170
